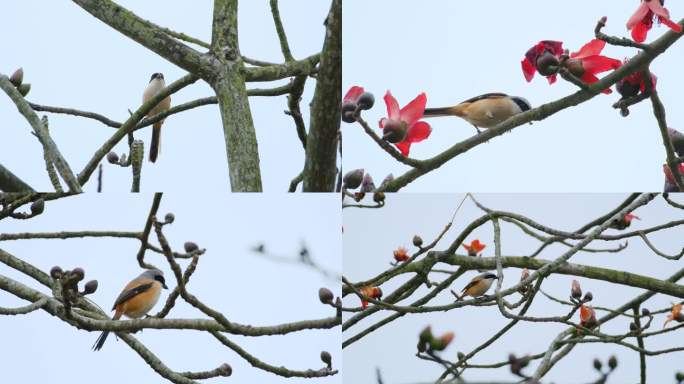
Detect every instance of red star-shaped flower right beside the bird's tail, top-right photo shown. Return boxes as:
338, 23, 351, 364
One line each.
379, 91, 432, 156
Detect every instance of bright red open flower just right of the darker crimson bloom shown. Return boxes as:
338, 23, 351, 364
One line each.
566, 39, 622, 94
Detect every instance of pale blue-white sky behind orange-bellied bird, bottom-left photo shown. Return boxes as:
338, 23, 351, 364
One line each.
0, 193, 342, 384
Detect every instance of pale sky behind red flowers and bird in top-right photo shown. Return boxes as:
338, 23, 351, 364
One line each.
343, 0, 684, 192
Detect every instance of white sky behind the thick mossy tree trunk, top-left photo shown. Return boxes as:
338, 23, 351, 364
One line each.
0, 0, 330, 191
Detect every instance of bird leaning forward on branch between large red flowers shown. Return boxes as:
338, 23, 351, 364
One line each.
425, 93, 532, 133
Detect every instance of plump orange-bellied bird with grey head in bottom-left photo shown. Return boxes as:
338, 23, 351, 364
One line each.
93, 269, 168, 351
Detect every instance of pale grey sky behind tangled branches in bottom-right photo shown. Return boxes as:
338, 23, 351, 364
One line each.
343, 194, 684, 384
